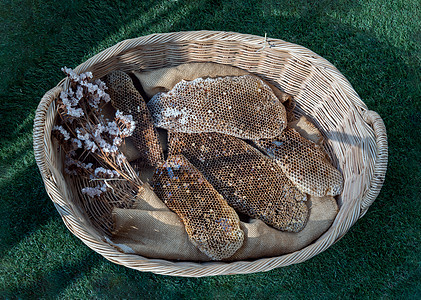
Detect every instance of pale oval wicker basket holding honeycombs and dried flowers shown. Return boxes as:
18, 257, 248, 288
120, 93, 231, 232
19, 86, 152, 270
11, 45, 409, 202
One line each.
34, 31, 387, 277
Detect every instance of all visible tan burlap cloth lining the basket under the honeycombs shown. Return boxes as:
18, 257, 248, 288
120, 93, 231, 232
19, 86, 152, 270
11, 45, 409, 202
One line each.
107, 63, 338, 261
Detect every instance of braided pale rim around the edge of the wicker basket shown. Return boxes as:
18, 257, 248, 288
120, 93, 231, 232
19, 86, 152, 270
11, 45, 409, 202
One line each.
34, 31, 387, 277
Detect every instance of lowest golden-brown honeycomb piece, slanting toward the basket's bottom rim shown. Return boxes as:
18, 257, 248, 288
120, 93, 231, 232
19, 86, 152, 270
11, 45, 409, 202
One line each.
152, 155, 244, 260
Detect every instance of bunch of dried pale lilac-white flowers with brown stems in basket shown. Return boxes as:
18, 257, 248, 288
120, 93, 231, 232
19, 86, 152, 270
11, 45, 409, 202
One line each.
53, 67, 136, 198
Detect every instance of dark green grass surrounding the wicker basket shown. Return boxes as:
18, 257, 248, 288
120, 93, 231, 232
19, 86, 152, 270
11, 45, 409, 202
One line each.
0, 0, 421, 299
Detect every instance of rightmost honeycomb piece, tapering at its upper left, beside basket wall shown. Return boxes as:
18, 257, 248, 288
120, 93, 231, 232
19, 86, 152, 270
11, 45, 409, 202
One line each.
255, 127, 343, 197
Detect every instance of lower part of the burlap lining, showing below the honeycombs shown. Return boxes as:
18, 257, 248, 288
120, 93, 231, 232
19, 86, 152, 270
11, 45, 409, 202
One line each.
111, 184, 338, 261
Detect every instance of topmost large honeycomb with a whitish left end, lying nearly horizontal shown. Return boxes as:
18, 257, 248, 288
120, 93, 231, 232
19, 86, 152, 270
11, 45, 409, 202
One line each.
148, 75, 286, 140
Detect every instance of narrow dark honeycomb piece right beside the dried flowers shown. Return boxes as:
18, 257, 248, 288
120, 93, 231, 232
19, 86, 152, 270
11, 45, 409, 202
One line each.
105, 71, 164, 166
